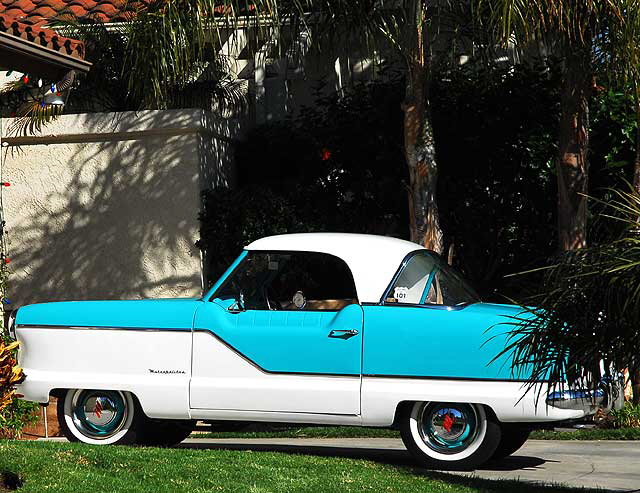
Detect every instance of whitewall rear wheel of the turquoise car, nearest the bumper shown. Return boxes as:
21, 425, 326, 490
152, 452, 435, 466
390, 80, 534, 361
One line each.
400, 402, 500, 469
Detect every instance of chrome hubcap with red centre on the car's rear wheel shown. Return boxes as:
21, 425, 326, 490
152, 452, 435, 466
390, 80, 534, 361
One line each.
417, 402, 478, 454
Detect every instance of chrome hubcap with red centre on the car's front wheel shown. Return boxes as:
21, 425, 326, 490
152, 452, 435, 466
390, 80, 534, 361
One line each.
71, 390, 127, 439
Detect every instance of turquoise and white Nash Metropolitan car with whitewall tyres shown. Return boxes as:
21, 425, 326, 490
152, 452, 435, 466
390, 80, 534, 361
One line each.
10, 233, 607, 468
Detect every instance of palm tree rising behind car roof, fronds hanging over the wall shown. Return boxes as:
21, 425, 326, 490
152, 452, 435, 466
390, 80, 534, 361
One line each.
8, 0, 476, 252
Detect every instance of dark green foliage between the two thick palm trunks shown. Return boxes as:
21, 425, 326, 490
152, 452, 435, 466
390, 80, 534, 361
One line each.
432, 64, 559, 301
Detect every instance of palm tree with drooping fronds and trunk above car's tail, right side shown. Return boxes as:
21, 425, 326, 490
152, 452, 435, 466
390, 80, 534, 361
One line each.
478, 0, 624, 251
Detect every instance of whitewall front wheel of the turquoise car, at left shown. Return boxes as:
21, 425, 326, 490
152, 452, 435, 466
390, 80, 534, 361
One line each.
58, 389, 143, 445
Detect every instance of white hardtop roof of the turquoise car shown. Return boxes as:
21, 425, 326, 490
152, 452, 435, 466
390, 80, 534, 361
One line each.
245, 233, 424, 303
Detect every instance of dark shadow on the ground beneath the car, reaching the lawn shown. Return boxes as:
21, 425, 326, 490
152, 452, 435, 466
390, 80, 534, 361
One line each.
178, 443, 596, 493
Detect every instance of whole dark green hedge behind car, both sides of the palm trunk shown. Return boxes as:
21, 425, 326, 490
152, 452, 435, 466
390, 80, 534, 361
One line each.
202, 62, 558, 294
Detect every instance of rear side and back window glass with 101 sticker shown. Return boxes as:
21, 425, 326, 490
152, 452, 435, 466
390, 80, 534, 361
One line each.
384, 251, 480, 306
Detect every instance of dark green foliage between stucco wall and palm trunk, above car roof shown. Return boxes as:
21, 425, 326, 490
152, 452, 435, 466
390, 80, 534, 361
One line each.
200, 77, 408, 282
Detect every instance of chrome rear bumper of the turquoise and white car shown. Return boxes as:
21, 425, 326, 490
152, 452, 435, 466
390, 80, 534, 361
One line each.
546, 378, 624, 416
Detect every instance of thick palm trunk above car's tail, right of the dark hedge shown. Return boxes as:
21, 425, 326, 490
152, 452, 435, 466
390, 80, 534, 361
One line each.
557, 53, 593, 251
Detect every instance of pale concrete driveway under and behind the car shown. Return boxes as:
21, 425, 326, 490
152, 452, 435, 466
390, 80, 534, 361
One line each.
180, 438, 640, 492
